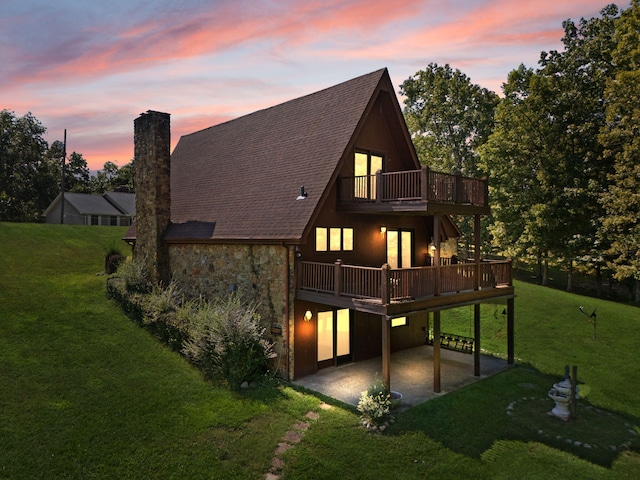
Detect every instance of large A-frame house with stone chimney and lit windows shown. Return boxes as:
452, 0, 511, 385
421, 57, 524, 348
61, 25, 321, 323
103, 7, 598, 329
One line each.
125, 69, 514, 391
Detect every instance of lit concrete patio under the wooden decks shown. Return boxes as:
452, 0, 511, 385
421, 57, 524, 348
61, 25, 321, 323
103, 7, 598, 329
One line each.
293, 345, 510, 410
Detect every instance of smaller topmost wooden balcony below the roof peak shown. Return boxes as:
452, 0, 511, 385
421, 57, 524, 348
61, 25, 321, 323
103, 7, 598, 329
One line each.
338, 167, 489, 215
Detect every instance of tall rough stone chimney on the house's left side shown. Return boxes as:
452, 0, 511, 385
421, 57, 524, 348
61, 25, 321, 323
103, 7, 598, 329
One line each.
133, 110, 171, 284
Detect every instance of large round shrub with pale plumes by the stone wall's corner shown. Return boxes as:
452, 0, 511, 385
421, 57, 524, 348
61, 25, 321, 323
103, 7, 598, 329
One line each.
183, 293, 275, 389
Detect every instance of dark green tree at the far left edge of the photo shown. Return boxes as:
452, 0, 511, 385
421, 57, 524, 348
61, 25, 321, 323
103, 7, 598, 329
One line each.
0, 110, 57, 222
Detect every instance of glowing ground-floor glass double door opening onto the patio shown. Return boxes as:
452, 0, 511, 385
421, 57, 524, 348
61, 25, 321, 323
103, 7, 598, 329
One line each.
317, 309, 352, 370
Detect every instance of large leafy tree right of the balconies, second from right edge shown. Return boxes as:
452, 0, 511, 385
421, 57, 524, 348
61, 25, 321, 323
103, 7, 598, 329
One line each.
483, 5, 619, 290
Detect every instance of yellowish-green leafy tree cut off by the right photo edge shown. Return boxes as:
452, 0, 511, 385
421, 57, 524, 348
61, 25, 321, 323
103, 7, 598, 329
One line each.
599, 0, 640, 302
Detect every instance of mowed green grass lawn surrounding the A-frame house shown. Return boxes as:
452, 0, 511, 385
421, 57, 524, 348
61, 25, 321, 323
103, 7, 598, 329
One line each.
0, 224, 640, 479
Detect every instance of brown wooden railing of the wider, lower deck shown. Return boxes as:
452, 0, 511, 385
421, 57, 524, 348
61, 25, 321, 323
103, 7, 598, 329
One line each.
298, 260, 511, 303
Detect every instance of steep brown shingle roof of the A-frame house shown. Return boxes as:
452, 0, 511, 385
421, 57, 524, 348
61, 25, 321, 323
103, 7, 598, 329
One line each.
171, 69, 392, 240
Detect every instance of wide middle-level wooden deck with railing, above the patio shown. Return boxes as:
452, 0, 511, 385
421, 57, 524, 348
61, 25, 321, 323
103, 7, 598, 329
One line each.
296, 260, 513, 315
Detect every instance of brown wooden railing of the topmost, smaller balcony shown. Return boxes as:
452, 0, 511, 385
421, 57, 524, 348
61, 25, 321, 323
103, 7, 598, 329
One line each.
338, 167, 488, 206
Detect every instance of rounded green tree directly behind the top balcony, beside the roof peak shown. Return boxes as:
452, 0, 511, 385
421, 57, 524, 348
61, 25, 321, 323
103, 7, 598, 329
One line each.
400, 63, 499, 176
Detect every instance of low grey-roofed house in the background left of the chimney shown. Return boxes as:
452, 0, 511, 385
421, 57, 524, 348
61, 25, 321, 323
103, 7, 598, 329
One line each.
42, 192, 136, 226
